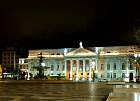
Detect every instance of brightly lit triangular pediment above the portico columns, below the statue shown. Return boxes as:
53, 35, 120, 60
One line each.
66, 48, 96, 56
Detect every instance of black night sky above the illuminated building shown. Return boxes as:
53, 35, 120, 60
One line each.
0, 0, 139, 49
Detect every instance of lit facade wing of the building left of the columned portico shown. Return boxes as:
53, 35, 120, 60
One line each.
28, 49, 65, 77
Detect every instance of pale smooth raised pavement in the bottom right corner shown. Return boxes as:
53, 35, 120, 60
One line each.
107, 83, 140, 101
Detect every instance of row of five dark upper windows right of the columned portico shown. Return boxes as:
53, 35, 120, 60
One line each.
101, 63, 134, 70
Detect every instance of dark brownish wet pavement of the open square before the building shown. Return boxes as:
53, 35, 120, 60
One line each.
0, 83, 112, 101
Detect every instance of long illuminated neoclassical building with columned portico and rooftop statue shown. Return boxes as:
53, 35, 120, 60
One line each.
24, 42, 139, 81
